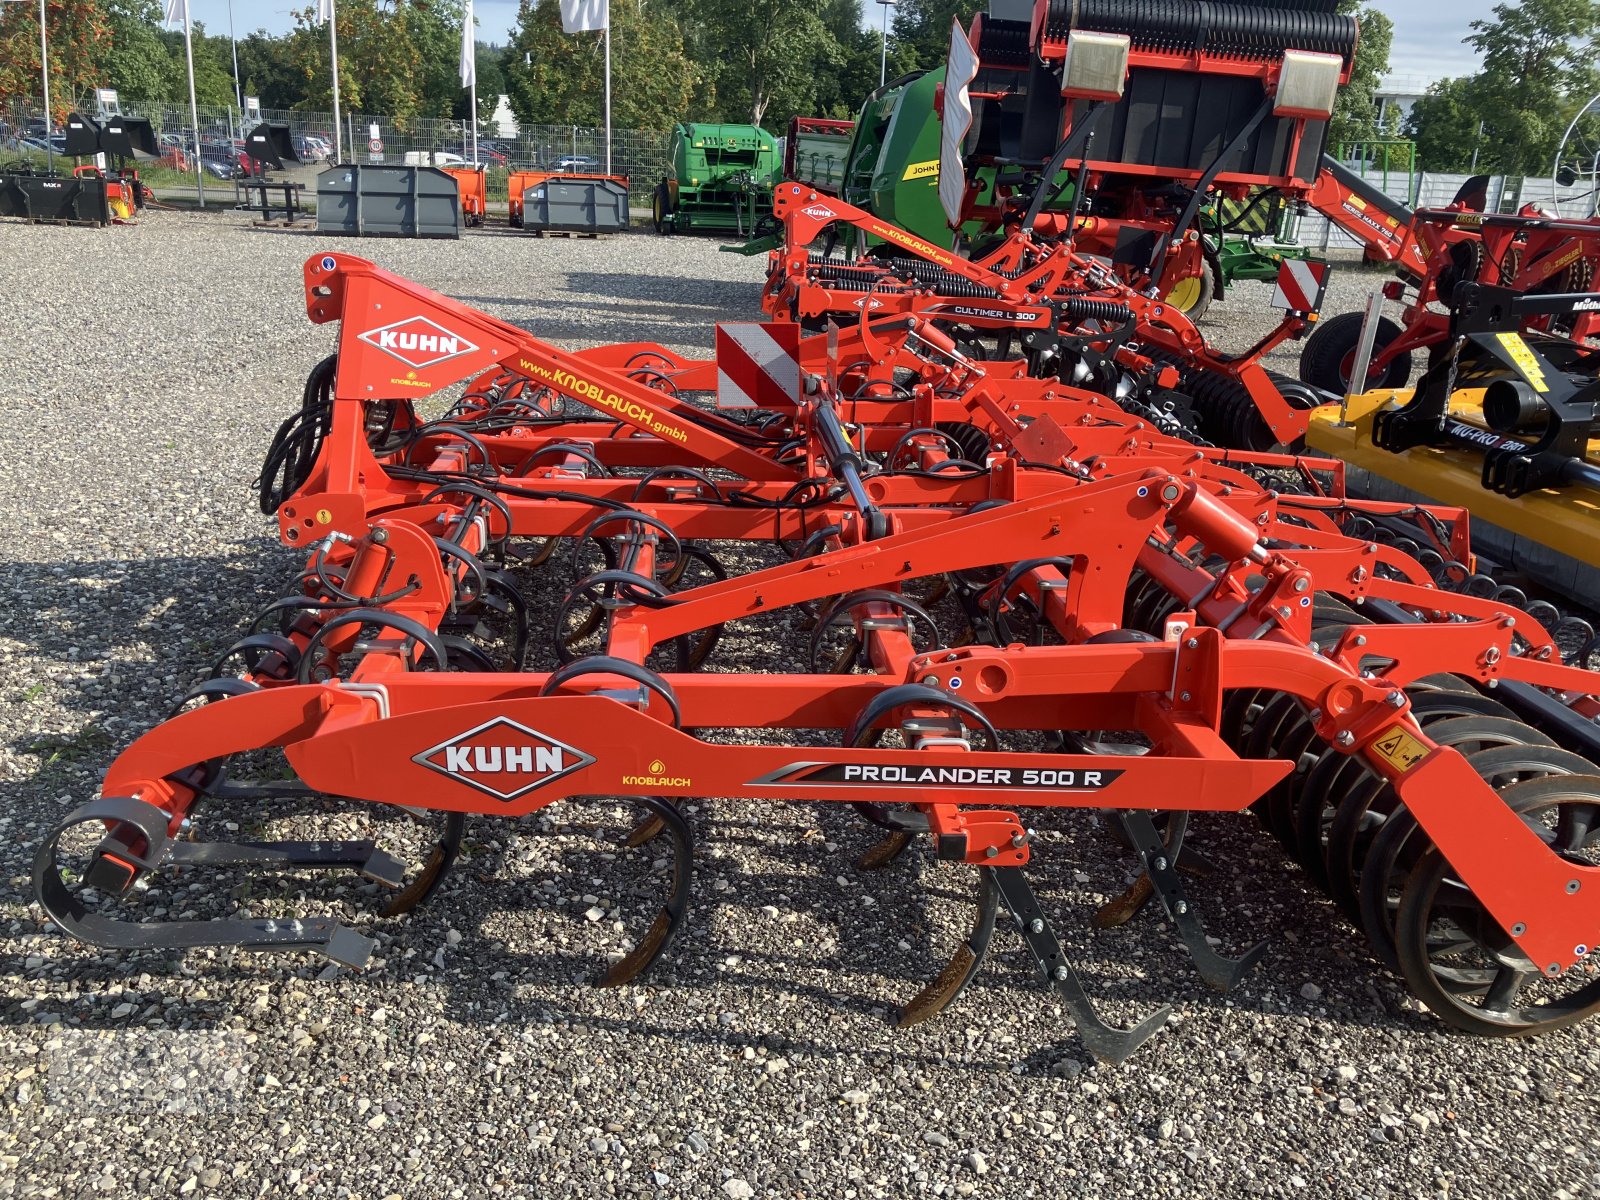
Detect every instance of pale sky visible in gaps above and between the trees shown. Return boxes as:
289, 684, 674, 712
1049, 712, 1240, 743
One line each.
189, 0, 1515, 82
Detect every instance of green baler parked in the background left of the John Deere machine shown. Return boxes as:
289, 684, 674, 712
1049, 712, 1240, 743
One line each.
651, 123, 782, 235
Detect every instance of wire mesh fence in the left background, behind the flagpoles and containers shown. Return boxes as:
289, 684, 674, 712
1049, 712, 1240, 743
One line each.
0, 98, 670, 198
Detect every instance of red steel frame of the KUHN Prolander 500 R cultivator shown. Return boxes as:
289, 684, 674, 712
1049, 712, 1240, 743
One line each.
35, 251, 1600, 1056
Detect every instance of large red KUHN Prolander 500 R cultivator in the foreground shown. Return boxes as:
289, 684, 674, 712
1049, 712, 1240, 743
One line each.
35, 254, 1600, 1061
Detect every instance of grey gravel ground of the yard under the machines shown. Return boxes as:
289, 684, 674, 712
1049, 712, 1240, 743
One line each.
0, 213, 1600, 1200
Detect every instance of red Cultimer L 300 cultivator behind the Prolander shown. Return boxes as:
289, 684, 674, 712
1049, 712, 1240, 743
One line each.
762, 184, 1315, 450
